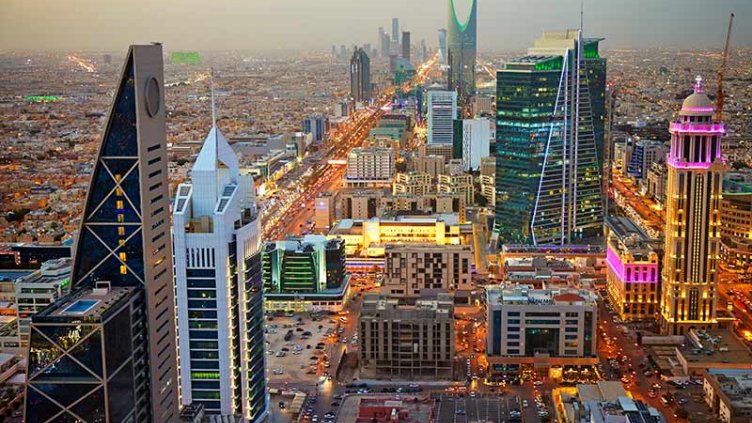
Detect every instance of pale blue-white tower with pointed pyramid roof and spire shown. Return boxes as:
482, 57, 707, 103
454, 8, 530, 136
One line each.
172, 120, 269, 422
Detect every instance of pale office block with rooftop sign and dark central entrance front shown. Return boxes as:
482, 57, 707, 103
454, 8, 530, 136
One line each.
486, 285, 598, 379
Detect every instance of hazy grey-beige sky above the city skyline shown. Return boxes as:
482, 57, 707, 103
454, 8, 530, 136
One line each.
0, 0, 752, 51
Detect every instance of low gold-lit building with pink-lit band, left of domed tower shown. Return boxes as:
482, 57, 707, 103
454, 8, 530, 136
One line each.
606, 216, 661, 322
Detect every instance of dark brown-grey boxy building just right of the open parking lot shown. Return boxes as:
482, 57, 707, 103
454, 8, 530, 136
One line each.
358, 294, 455, 380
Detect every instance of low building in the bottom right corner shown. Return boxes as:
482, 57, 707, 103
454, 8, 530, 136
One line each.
703, 369, 752, 423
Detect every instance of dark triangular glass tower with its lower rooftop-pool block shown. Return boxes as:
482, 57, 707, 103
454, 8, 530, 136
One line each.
25, 45, 178, 423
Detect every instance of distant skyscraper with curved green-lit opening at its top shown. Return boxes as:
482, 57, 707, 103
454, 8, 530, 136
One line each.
447, 0, 478, 105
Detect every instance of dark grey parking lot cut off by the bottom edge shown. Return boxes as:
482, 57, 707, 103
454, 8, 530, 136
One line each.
436, 395, 521, 423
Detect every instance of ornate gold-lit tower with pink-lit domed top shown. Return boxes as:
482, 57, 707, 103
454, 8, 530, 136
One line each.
661, 77, 726, 335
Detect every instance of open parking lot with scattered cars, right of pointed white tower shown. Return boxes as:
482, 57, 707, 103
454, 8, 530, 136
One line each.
266, 313, 352, 384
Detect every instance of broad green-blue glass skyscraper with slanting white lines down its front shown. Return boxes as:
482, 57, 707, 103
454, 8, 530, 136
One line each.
495, 30, 603, 244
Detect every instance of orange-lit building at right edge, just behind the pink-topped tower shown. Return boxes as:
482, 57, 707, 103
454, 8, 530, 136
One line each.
721, 192, 752, 272
